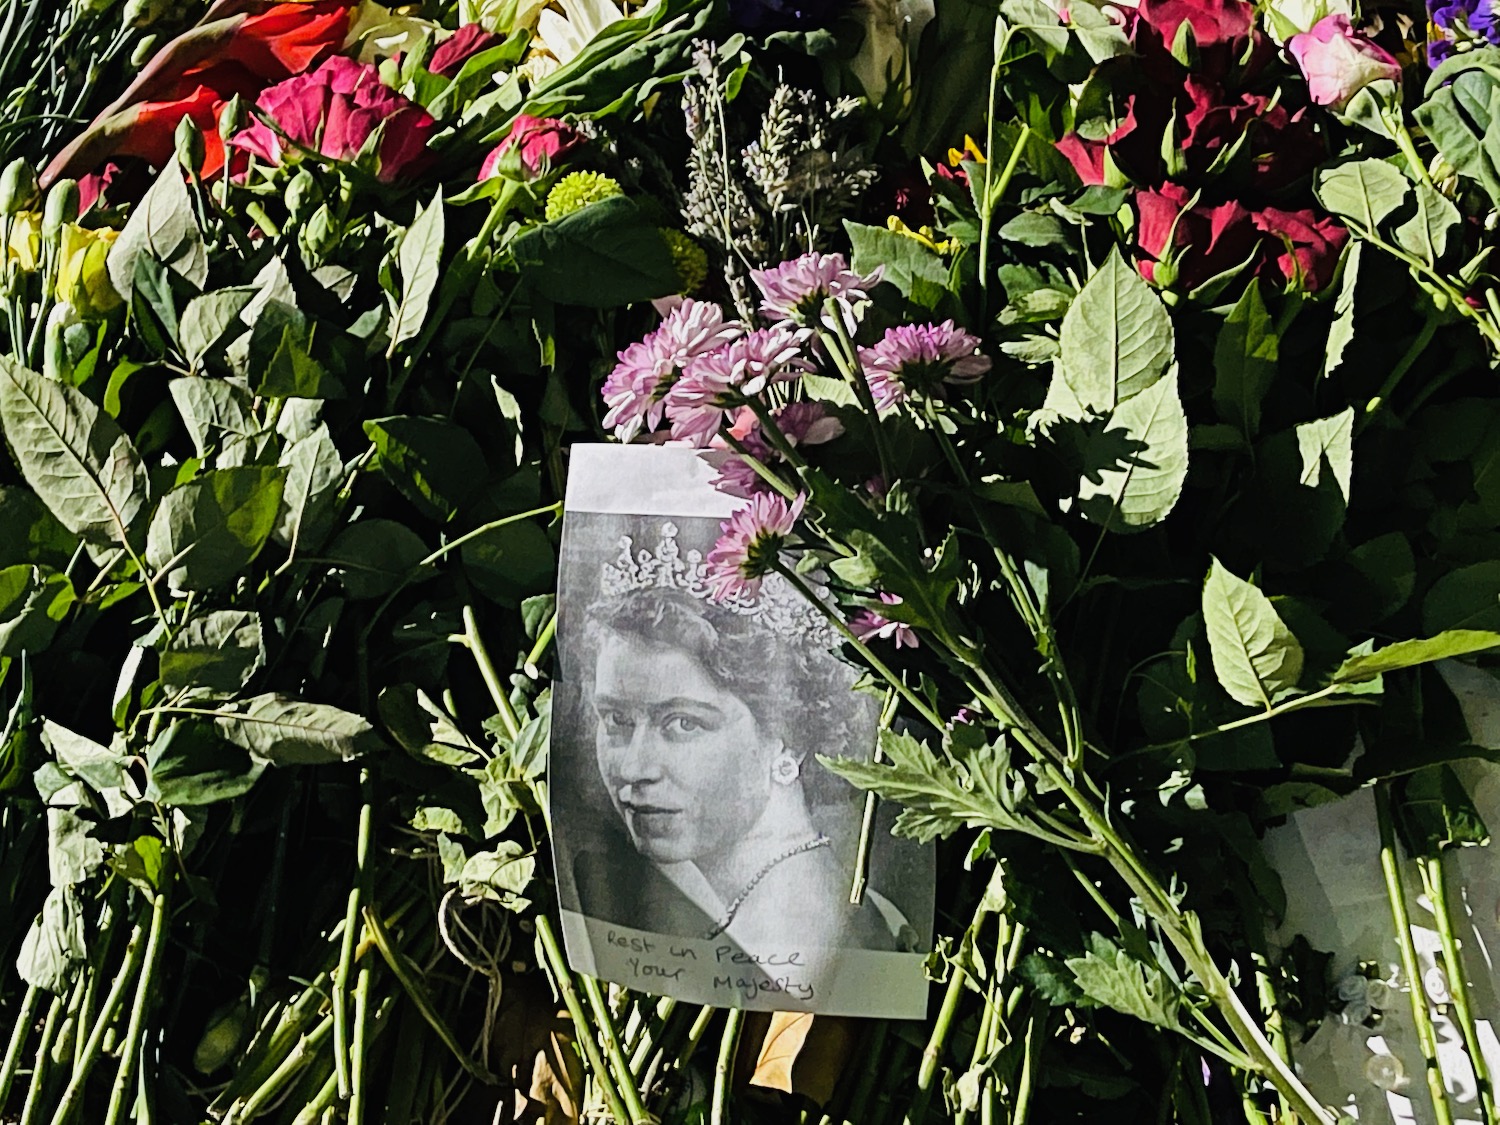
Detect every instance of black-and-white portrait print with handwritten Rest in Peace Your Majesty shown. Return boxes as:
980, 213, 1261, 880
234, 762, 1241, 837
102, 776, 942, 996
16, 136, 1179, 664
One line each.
551, 446, 933, 1017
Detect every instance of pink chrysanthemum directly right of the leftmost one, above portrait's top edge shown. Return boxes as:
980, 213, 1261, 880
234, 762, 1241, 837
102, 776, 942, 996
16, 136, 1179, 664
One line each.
663, 329, 812, 447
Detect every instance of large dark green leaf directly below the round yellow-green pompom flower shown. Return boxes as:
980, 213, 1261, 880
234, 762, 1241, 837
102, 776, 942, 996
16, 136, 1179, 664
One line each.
512, 195, 681, 309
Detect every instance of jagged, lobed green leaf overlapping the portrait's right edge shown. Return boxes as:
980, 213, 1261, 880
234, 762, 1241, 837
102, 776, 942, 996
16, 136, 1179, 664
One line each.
818, 731, 1028, 843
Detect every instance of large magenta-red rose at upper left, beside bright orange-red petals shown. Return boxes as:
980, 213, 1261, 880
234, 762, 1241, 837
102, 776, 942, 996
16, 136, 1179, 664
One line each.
230, 56, 437, 183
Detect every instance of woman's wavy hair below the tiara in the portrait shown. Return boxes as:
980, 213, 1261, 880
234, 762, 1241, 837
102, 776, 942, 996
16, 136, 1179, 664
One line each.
584, 588, 876, 806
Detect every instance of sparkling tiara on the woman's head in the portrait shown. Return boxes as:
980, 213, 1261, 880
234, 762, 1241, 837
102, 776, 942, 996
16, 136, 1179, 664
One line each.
599, 521, 840, 648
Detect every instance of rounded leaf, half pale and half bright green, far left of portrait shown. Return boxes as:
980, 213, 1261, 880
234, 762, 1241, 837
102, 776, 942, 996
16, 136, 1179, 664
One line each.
146, 465, 287, 590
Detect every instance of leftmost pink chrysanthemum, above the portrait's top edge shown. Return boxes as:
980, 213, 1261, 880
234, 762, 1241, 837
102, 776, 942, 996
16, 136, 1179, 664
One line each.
602, 299, 741, 441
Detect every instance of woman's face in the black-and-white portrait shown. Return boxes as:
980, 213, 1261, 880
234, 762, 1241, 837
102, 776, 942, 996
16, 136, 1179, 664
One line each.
594, 633, 780, 863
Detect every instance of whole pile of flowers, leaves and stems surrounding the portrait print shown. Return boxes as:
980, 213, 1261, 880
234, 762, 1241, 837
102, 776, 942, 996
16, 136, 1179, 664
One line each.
0, 0, 1500, 1125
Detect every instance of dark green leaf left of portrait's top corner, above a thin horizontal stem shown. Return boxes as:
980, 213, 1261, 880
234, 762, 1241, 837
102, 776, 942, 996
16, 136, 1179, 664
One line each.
365, 417, 489, 521
